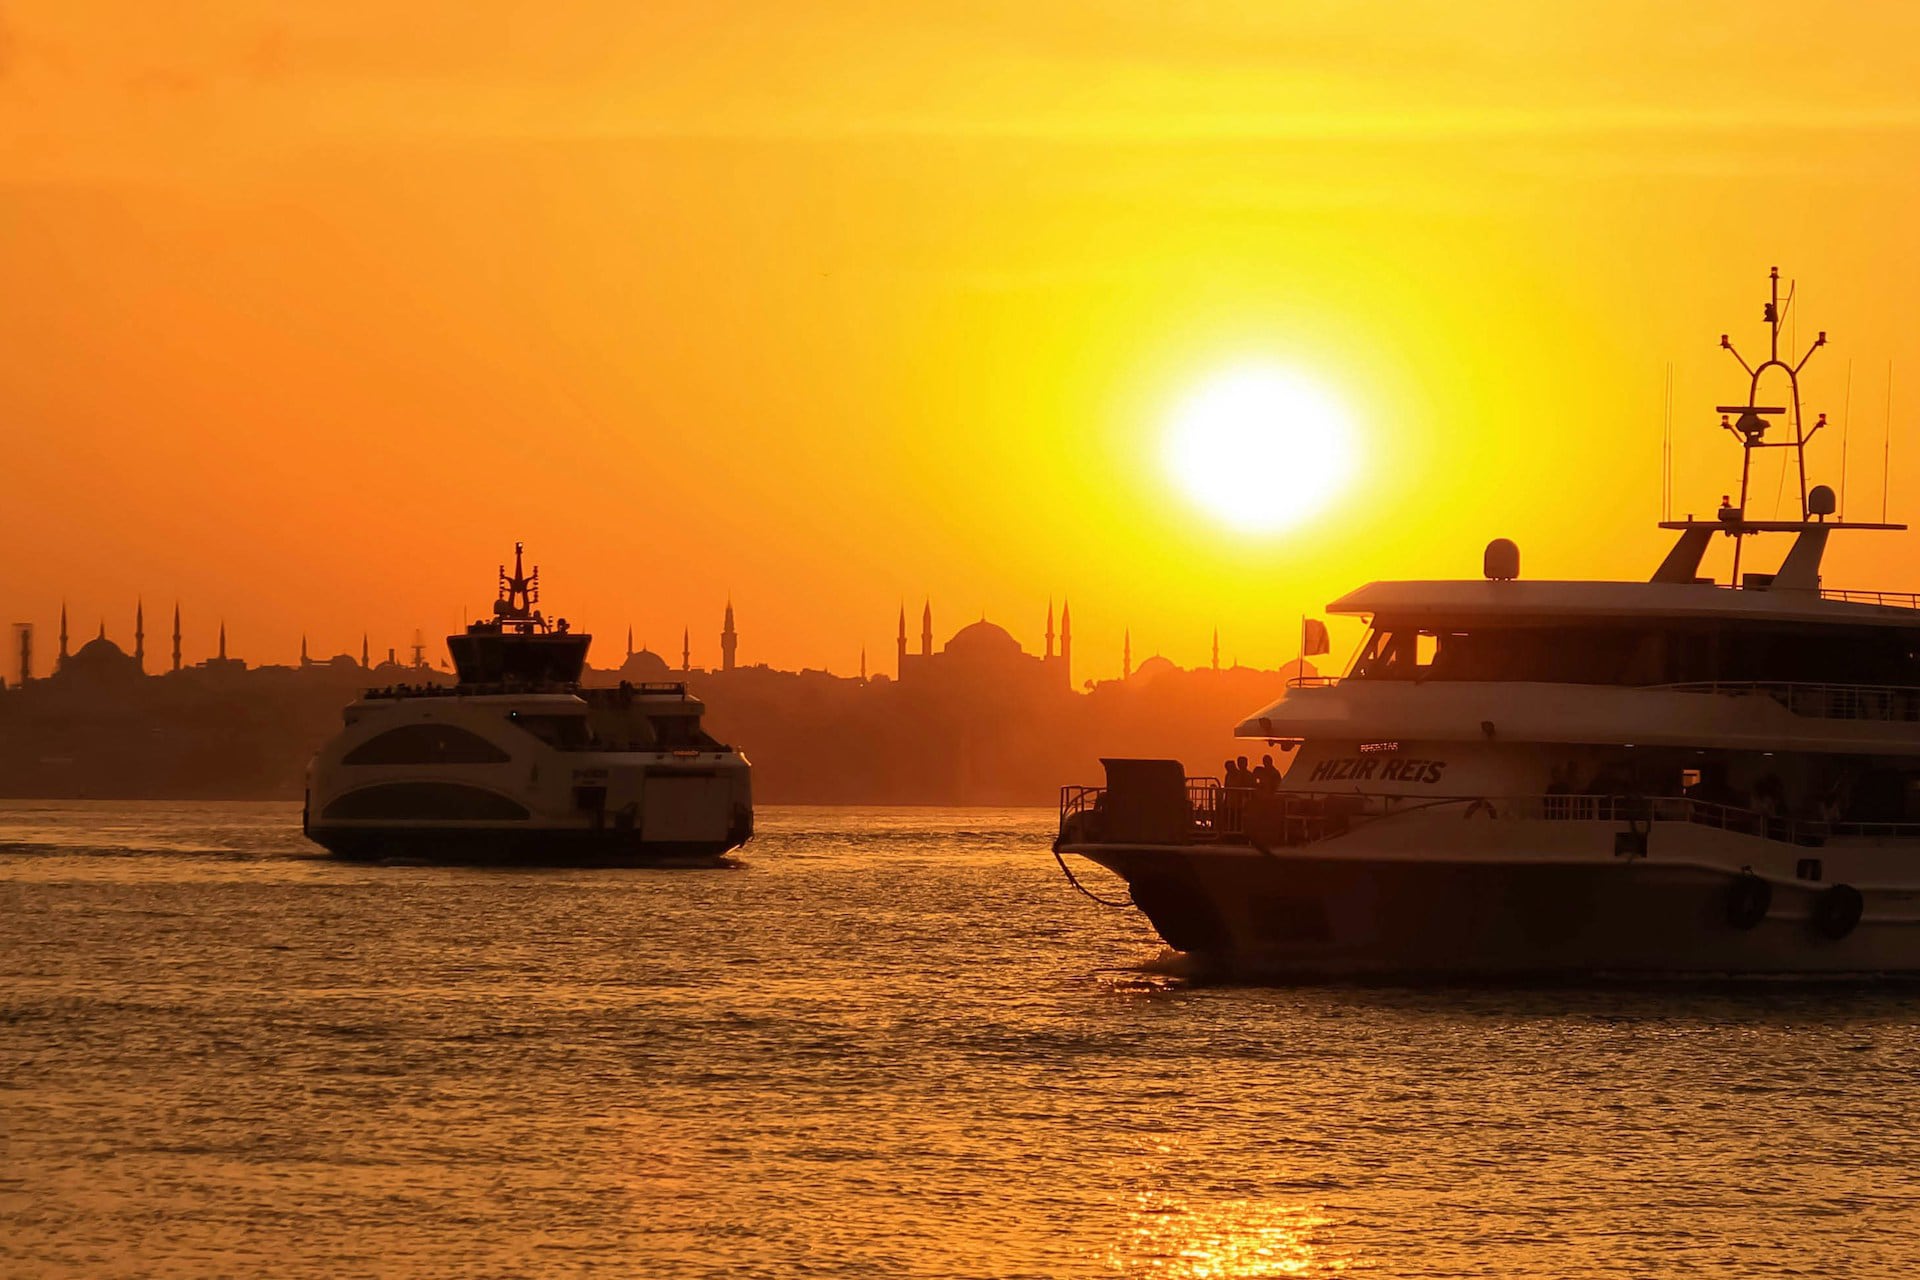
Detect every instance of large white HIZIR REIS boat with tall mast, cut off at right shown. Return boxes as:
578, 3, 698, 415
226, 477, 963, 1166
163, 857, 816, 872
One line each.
1054, 271, 1920, 979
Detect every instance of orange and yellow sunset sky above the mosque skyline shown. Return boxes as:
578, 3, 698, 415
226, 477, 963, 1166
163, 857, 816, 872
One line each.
0, 0, 1920, 676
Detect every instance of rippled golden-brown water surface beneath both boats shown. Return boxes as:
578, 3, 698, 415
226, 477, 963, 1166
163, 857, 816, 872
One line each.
0, 802, 1920, 1278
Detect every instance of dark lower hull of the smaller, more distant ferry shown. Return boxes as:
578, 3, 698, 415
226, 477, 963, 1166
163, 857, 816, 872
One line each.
307, 827, 745, 867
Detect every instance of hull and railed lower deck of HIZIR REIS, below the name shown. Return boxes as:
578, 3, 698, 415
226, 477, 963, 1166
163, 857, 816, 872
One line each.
1056, 762, 1920, 977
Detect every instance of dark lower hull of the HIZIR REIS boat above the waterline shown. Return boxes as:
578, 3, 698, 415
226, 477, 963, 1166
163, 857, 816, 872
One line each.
1062, 844, 1920, 981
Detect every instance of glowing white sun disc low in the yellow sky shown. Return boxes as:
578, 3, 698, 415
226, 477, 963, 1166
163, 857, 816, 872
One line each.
1164, 367, 1354, 533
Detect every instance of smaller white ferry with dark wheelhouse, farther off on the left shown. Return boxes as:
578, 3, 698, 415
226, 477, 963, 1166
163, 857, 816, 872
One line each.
301, 543, 753, 865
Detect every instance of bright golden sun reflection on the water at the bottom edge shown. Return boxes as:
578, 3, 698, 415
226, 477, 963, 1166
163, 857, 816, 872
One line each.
1108, 1194, 1350, 1280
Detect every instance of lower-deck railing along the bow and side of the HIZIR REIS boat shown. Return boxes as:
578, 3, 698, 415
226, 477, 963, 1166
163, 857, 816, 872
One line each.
1060, 779, 1920, 848
